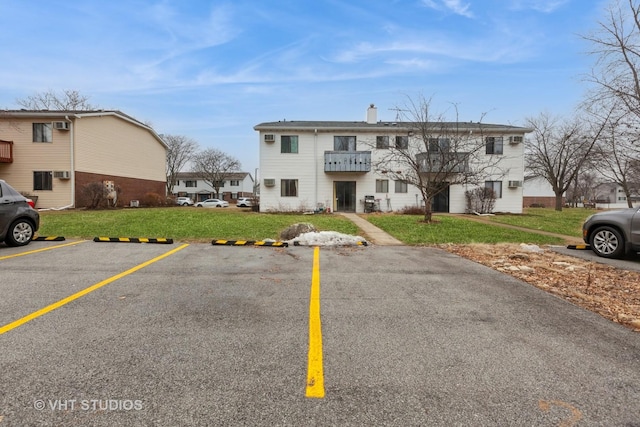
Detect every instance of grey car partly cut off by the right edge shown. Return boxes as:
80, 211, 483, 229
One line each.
582, 208, 640, 258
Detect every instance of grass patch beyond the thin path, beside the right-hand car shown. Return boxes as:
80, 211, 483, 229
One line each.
487, 208, 596, 237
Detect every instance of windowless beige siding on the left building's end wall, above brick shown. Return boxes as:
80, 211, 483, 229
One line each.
75, 116, 166, 181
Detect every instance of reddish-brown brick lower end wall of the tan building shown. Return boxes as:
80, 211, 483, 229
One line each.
75, 172, 166, 206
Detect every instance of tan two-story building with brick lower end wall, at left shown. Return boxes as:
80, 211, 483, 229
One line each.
0, 110, 167, 208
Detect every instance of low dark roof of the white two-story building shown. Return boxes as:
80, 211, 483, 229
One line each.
253, 120, 533, 133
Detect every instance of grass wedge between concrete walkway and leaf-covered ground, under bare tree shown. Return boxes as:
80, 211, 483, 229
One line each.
366, 215, 564, 245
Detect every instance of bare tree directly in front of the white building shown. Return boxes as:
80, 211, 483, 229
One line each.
370, 96, 507, 222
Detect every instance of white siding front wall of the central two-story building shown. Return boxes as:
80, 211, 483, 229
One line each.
259, 129, 524, 213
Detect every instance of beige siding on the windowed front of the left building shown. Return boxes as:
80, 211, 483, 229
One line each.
0, 118, 72, 207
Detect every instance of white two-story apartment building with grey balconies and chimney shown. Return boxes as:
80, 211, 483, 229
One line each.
254, 105, 531, 213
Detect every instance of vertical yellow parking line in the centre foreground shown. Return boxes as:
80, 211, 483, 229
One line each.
305, 246, 324, 398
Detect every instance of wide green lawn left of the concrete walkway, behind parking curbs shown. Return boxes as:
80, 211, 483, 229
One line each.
38, 207, 358, 242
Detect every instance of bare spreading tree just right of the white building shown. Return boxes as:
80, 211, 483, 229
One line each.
525, 109, 609, 211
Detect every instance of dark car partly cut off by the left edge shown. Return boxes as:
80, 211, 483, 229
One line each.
0, 179, 40, 246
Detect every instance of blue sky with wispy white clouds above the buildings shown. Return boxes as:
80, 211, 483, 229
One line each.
0, 0, 608, 173
